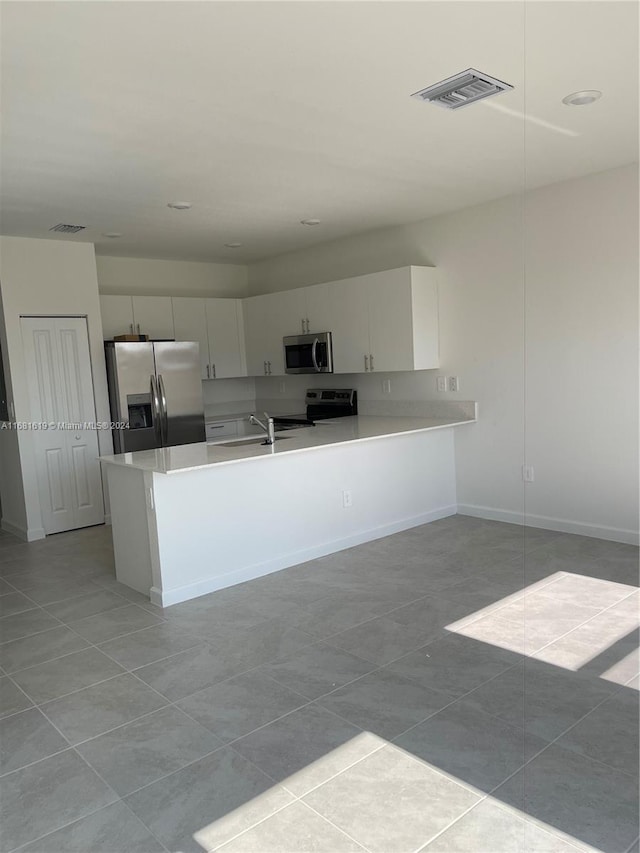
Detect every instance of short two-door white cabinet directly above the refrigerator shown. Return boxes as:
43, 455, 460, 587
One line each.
100, 295, 174, 340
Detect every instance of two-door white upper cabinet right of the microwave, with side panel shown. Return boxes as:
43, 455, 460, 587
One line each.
331, 267, 439, 373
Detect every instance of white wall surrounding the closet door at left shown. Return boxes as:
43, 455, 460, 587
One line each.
0, 237, 113, 539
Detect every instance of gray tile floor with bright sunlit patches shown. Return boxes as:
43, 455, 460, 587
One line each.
0, 516, 639, 853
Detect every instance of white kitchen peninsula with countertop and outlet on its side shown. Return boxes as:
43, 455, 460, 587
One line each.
101, 412, 476, 607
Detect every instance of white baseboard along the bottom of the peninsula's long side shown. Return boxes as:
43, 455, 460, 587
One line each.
149, 505, 457, 607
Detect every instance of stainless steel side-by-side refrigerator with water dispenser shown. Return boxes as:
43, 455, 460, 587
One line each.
105, 341, 205, 453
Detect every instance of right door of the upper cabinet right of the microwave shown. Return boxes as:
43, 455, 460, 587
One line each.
364, 267, 414, 372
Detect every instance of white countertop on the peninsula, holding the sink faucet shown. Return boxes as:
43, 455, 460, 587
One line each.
100, 415, 475, 474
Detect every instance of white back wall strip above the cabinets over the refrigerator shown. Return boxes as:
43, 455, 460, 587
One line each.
96, 255, 247, 297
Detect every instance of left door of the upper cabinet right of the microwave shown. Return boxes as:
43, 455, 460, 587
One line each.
328, 276, 370, 373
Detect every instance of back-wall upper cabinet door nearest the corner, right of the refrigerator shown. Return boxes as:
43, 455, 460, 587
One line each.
205, 299, 247, 379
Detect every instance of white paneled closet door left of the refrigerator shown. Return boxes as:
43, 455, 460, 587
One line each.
21, 317, 104, 533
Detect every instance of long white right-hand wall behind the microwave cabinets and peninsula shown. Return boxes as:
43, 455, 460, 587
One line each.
249, 165, 638, 541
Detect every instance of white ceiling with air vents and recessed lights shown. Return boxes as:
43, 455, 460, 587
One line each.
0, 0, 638, 263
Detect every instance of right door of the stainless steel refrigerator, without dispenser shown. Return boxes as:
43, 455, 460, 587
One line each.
153, 341, 205, 446
